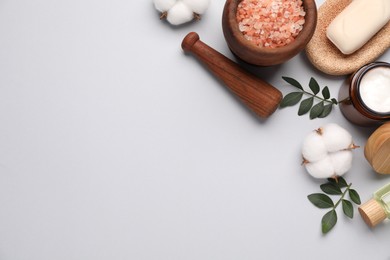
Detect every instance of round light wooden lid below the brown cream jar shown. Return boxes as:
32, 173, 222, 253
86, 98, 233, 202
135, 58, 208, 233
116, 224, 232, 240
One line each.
364, 123, 390, 174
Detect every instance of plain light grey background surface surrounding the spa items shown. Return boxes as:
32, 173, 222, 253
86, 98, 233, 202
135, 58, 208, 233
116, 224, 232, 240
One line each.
0, 0, 390, 260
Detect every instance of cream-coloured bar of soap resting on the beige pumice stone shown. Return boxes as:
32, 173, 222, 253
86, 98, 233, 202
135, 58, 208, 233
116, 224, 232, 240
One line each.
326, 0, 390, 54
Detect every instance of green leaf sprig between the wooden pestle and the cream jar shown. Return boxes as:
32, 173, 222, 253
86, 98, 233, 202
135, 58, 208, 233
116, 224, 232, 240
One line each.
280, 77, 339, 119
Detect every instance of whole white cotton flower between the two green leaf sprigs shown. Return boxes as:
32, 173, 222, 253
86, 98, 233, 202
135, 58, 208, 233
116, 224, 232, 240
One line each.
302, 123, 357, 178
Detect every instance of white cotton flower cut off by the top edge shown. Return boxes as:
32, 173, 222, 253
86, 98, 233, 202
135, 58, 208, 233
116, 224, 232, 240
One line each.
154, 0, 210, 25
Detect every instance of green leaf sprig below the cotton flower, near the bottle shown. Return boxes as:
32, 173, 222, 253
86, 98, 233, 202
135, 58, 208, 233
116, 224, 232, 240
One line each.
307, 177, 361, 234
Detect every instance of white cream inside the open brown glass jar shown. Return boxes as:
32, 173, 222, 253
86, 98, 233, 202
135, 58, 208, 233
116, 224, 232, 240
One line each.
359, 67, 390, 113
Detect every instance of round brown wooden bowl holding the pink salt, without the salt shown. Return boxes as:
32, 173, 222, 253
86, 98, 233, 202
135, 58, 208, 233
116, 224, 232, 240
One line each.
222, 0, 317, 66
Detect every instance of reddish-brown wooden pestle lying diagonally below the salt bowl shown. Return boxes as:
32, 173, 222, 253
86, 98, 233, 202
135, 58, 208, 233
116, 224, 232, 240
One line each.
181, 32, 282, 118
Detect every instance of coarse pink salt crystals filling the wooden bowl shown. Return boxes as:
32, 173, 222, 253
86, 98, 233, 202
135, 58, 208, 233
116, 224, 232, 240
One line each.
236, 0, 306, 48
